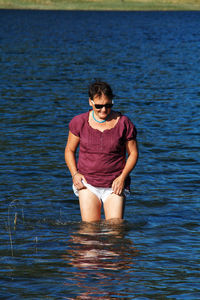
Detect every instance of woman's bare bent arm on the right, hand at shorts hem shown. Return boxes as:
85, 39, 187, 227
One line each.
112, 140, 138, 195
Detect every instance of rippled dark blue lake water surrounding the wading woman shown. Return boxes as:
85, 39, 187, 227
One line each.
0, 10, 200, 300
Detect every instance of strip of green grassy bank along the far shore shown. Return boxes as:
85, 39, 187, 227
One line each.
0, 0, 200, 10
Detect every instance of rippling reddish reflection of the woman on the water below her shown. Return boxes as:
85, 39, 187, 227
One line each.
63, 220, 139, 299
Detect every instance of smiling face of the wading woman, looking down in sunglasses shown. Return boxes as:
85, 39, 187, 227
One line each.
90, 94, 112, 120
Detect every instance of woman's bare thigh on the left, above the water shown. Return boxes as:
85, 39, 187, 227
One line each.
79, 189, 101, 222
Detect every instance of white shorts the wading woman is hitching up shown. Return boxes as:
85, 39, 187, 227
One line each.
72, 181, 130, 203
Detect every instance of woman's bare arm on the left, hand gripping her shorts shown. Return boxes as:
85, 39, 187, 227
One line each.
65, 131, 86, 190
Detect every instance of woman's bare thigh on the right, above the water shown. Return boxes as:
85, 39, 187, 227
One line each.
104, 193, 125, 220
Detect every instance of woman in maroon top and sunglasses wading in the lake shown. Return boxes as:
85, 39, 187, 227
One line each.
65, 81, 138, 222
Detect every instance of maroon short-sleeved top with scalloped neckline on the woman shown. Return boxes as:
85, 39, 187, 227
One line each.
69, 111, 136, 188
